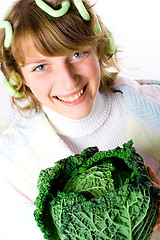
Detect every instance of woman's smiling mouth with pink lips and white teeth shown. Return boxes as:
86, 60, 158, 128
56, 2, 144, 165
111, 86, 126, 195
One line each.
53, 85, 87, 105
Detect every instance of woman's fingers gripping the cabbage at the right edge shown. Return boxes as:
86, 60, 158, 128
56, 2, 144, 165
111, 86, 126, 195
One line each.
147, 166, 160, 232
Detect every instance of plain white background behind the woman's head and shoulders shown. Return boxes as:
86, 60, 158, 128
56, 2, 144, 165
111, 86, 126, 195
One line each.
0, 0, 160, 121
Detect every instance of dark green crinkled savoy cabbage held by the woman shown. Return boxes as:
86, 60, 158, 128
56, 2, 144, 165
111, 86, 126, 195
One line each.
34, 141, 159, 240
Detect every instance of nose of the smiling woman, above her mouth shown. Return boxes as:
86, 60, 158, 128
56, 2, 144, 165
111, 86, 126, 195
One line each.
60, 62, 78, 91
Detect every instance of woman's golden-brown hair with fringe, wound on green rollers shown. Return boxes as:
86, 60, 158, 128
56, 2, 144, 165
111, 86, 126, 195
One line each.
0, 0, 119, 112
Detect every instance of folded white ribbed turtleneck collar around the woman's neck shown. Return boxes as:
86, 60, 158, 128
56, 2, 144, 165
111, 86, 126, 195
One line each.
43, 92, 111, 138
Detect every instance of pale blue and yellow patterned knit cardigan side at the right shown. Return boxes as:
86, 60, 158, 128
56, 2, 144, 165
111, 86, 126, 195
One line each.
115, 78, 160, 178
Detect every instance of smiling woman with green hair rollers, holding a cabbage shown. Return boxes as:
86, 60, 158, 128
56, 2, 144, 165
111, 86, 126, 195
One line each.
0, 0, 160, 240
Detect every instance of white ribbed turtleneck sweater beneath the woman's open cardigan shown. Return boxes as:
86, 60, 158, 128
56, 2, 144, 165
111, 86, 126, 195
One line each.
43, 92, 126, 153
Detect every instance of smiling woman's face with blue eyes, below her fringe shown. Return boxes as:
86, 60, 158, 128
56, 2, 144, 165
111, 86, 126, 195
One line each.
21, 46, 100, 119
